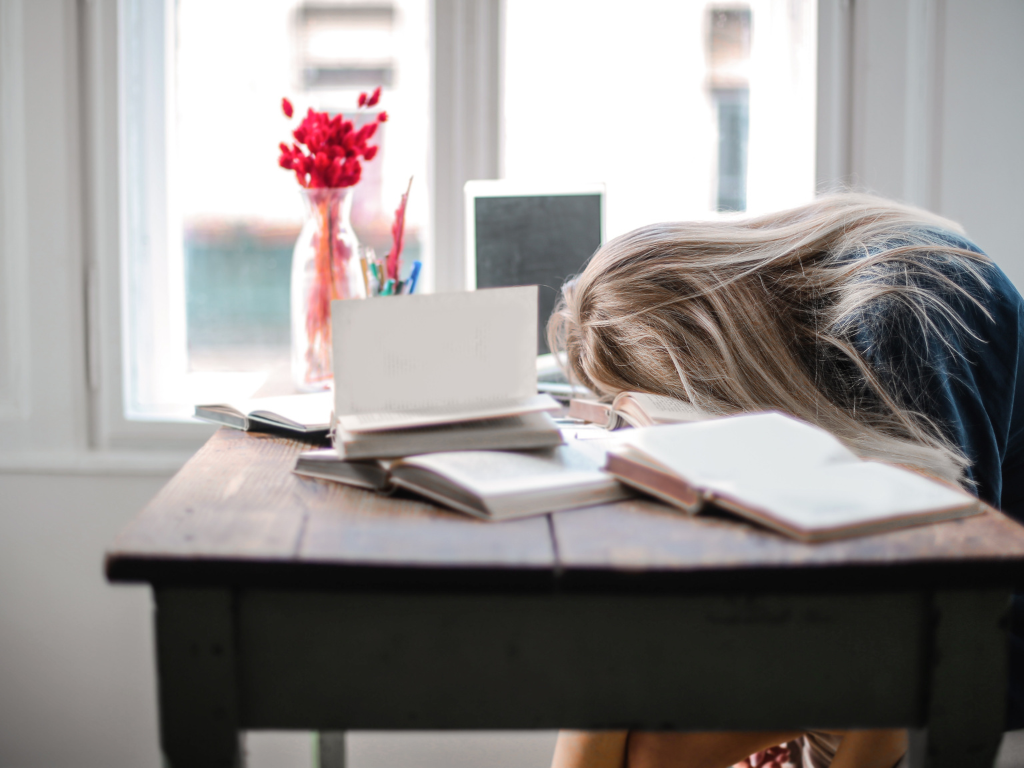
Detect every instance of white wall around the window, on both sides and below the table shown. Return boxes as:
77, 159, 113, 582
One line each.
0, 0, 1024, 768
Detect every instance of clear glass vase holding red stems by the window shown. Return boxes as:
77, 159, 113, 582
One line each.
292, 186, 366, 392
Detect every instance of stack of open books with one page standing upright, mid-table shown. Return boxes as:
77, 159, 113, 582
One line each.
295, 286, 631, 519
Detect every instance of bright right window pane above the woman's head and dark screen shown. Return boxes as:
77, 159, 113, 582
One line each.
502, 0, 816, 237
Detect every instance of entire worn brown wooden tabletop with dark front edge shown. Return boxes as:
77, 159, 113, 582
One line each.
106, 428, 1024, 592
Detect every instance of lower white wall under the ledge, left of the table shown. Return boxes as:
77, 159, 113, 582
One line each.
0, 474, 167, 768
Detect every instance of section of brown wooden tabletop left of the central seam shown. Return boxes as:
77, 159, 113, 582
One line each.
106, 428, 555, 583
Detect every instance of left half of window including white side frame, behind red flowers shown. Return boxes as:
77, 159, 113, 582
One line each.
122, 0, 430, 419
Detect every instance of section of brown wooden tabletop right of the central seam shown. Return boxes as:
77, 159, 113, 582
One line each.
552, 500, 1024, 589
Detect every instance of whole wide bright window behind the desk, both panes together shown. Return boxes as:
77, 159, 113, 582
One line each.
114, 0, 816, 434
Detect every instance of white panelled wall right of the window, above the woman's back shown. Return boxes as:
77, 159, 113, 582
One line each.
818, 0, 1024, 288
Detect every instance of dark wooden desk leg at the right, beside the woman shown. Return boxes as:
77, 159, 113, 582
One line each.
910, 590, 1010, 768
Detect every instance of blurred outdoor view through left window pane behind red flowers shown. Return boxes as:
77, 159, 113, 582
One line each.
172, 0, 429, 379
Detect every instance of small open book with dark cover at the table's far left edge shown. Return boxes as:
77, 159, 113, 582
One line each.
196, 392, 334, 434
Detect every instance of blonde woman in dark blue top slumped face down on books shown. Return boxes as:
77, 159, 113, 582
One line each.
548, 195, 1024, 768
